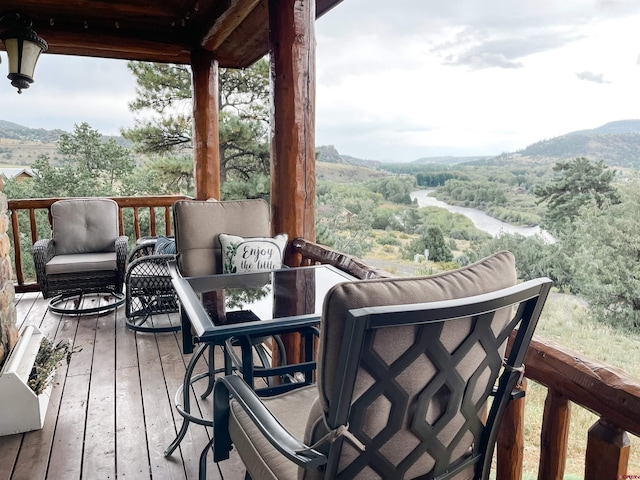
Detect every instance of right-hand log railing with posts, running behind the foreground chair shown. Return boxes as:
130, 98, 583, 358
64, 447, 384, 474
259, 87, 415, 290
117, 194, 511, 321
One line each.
292, 238, 640, 480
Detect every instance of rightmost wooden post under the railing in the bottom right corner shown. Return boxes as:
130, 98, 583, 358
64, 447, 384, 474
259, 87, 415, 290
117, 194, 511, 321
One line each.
584, 418, 631, 480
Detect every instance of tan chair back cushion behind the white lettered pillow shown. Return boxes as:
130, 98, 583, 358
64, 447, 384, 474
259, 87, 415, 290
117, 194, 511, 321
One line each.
173, 199, 271, 277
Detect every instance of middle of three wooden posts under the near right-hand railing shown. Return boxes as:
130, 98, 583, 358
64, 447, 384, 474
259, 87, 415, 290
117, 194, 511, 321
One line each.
538, 388, 571, 480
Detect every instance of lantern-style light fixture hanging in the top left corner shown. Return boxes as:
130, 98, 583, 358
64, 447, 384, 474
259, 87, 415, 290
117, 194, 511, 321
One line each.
0, 13, 49, 93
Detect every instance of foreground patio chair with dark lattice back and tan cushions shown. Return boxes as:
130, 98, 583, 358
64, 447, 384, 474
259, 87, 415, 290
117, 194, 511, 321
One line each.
212, 252, 551, 480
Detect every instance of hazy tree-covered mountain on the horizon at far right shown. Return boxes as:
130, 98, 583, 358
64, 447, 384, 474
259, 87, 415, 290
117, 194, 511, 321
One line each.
510, 120, 640, 169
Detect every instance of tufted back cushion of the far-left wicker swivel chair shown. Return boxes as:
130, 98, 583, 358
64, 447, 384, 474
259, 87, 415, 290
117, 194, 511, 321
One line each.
51, 198, 119, 255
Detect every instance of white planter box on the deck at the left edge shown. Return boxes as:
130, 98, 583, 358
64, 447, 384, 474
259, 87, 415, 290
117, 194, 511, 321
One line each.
0, 325, 51, 435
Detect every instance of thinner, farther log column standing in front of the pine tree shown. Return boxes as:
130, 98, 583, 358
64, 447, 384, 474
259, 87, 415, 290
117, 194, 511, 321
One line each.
191, 50, 220, 200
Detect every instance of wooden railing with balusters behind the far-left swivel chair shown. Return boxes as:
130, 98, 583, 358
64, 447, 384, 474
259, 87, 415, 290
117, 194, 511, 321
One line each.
8, 195, 189, 292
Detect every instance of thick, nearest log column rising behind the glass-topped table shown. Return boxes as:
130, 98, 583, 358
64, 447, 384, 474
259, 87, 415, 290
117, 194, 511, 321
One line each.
269, 0, 316, 265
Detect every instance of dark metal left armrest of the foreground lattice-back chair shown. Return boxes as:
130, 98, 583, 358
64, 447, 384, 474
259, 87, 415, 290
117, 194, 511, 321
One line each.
213, 375, 327, 469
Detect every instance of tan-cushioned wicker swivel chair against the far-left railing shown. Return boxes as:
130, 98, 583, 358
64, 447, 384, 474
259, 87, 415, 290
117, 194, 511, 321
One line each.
33, 198, 127, 315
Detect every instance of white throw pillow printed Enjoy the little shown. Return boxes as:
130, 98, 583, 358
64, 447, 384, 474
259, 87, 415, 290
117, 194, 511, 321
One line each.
218, 233, 288, 273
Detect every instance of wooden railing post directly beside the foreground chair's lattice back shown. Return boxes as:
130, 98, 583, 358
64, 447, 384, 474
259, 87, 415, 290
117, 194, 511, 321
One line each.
496, 378, 527, 480
